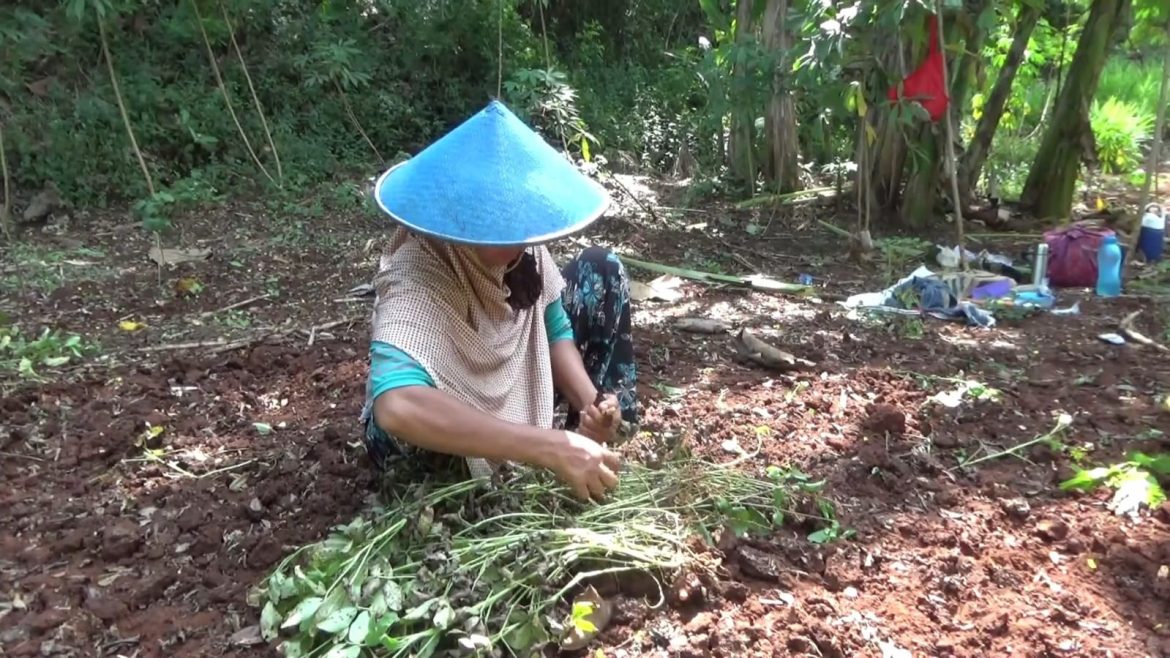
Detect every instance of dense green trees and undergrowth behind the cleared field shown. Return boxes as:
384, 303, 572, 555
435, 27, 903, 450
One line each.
0, 0, 1170, 231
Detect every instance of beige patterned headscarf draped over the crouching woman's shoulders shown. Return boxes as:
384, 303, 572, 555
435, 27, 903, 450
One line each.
372, 229, 565, 478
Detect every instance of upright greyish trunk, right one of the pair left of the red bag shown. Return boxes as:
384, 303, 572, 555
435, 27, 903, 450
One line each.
764, 0, 800, 193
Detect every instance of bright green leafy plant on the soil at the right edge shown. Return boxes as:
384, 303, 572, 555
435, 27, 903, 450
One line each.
1060, 452, 1170, 515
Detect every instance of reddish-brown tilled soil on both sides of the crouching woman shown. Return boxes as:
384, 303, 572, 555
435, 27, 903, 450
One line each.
0, 195, 1170, 658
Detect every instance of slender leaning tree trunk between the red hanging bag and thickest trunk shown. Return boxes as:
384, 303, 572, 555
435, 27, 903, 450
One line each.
959, 5, 1040, 200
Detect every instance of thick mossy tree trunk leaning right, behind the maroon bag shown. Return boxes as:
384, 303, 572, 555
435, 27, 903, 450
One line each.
1020, 0, 1130, 218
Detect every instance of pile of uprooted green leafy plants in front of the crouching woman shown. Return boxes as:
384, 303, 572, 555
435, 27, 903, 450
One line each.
249, 460, 828, 657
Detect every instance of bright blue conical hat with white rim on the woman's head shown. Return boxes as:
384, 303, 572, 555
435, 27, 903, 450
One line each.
374, 101, 610, 246
